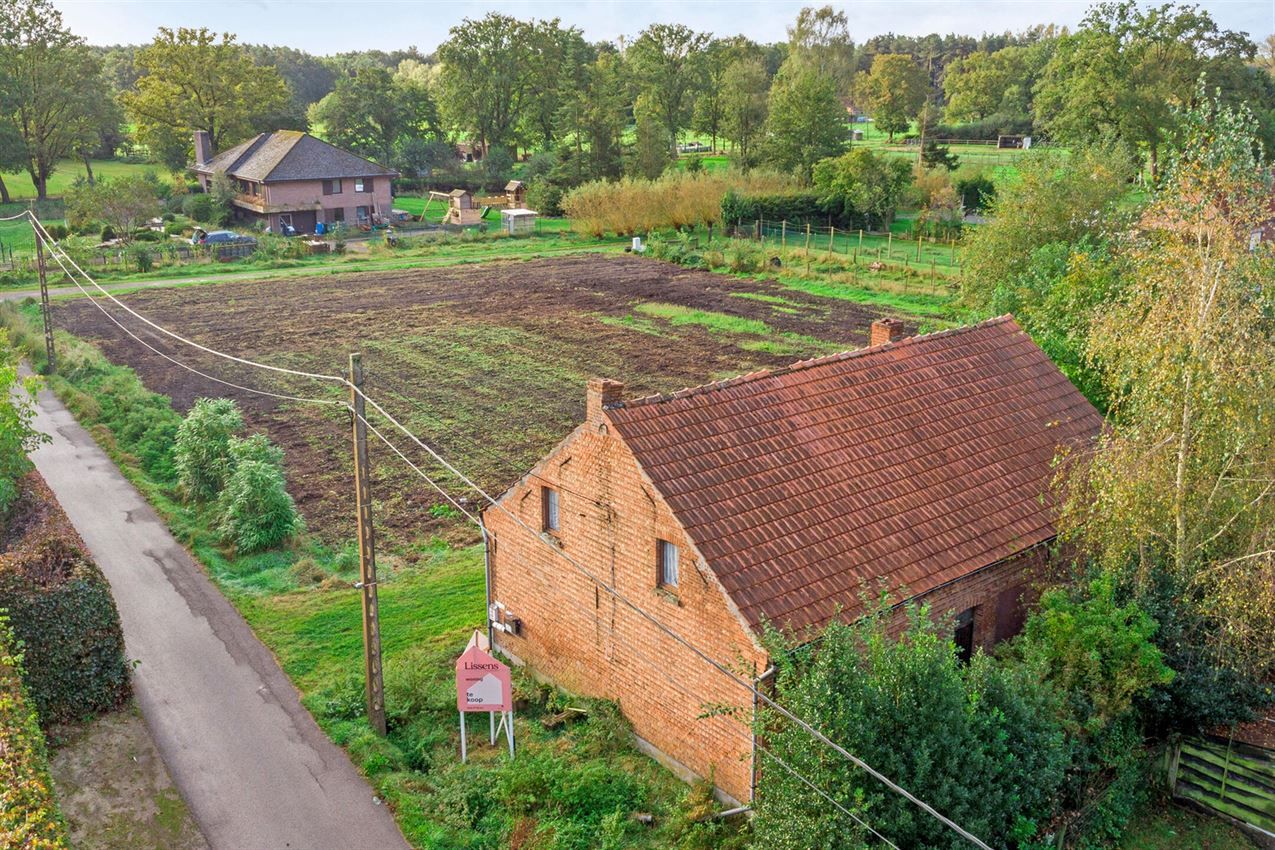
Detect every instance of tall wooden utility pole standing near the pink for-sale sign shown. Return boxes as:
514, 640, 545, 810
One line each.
349, 354, 385, 735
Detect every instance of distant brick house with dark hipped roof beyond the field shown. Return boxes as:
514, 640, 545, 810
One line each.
193, 130, 398, 233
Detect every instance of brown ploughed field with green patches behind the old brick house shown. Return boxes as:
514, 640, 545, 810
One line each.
55, 256, 897, 540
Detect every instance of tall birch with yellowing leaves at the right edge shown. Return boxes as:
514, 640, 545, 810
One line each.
1062, 93, 1275, 679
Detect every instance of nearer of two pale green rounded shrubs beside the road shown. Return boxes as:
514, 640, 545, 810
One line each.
217, 435, 305, 553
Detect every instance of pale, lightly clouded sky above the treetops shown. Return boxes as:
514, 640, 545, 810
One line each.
54, 0, 1275, 54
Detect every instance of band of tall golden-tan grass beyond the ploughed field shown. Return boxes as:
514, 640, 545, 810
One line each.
562, 171, 792, 237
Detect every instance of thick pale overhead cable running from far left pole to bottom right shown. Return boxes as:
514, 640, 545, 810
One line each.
32, 215, 992, 850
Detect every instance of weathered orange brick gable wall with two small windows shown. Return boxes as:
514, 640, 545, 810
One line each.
485, 419, 766, 800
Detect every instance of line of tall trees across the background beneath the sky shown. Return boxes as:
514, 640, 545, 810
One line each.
0, 0, 1275, 200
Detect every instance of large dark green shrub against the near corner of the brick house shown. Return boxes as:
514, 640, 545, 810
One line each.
755, 608, 1067, 850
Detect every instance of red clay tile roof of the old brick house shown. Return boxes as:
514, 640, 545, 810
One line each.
606, 316, 1102, 628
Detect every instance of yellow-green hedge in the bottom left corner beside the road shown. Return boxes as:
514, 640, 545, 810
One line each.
0, 612, 68, 850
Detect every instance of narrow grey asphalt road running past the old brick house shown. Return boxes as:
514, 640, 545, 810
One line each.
32, 379, 408, 850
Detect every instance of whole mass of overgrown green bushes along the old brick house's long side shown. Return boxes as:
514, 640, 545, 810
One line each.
756, 587, 1173, 850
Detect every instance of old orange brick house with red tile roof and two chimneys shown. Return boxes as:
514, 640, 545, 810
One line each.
483, 316, 1102, 800
